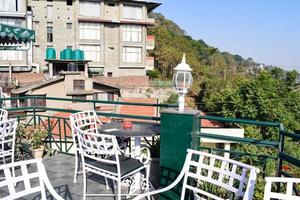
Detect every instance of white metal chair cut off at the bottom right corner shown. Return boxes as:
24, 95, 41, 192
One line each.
264, 177, 300, 200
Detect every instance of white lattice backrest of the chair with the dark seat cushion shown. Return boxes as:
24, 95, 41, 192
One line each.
77, 129, 120, 176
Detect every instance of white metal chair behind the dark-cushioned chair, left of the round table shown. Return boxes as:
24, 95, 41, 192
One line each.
70, 110, 102, 183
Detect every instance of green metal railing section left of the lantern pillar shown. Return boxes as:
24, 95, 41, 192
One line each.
0, 96, 177, 154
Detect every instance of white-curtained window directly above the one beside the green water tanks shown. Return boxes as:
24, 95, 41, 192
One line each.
79, 22, 101, 40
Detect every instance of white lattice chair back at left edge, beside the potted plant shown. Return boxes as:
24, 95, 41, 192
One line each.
0, 119, 18, 158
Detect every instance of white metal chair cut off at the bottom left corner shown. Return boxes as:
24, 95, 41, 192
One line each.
0, 159, 63, 200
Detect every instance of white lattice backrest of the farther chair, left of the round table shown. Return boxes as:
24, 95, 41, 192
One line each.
70, 110, 102, 136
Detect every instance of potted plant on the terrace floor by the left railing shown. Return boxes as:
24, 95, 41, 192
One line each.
30, 127, 47, 158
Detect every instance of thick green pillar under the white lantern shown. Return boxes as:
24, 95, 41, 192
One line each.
160, 109, 199, 200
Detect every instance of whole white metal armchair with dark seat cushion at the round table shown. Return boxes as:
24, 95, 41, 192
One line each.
77, 129, 150, 200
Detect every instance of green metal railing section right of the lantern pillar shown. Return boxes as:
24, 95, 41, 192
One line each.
197, 116, 300, 180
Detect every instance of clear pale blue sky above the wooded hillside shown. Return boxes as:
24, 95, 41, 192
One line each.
155, 0, 300, 70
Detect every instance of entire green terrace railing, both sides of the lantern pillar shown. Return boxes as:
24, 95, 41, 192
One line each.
0, 96, 300, 182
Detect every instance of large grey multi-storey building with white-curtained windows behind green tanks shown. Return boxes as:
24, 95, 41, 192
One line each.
0, 0, 160, 77
